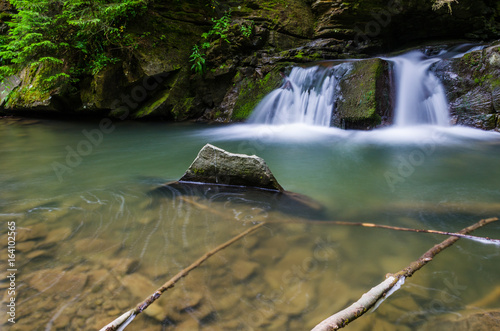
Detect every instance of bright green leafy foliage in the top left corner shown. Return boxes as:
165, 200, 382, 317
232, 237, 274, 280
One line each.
0, 0, 148, 88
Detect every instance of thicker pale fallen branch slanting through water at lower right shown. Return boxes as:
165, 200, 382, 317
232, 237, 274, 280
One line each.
312, 218, 498, 331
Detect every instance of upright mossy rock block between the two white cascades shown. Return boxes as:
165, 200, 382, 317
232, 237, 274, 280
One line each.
334, 58, 391, 129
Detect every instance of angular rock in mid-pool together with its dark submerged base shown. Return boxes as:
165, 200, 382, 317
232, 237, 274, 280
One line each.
150, 144, 325, 220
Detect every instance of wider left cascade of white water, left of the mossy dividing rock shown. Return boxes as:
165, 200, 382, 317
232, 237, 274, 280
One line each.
248, 63, 351, 126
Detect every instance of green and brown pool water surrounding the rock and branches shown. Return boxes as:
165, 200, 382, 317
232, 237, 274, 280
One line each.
0, 119, 500, 330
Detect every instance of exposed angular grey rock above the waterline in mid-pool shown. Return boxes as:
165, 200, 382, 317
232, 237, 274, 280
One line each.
179, 144, 284, 192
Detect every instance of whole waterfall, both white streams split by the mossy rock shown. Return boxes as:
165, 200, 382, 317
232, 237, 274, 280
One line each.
248, 44, 484, 127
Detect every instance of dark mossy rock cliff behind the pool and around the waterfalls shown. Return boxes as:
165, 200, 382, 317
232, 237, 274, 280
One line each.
0, 0, 500, 128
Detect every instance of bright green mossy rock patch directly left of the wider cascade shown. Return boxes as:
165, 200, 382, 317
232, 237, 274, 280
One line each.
231, 70, 282, 121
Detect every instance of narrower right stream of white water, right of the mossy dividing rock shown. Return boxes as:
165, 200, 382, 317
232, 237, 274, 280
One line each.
388, 51, 450, 126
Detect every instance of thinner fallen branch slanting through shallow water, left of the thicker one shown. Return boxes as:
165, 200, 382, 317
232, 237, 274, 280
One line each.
100, 222, 265, 331
